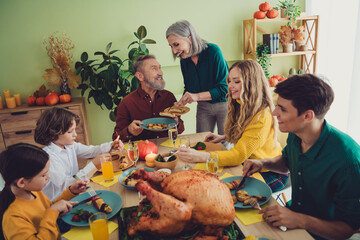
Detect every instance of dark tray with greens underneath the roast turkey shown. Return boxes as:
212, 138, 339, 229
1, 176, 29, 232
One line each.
118, 203, 245, 240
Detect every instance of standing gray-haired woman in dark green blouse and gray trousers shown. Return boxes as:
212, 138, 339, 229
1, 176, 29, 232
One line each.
166, 20, 229, 134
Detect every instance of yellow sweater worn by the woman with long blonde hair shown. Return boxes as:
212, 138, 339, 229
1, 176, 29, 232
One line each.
218, 108, 281, 166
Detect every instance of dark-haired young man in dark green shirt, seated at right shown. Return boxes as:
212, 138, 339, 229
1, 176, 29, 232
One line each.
244, 74, 360, 239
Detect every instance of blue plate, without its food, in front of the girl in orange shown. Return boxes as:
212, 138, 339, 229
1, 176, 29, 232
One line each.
62, 190, 123, 227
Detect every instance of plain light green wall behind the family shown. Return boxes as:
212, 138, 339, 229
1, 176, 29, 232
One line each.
0, 0, 305, 144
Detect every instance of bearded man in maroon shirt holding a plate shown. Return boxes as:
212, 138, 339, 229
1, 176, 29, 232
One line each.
113, 55, 184, 141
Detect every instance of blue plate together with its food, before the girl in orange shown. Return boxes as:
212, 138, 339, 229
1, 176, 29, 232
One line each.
62, 190, 123, 227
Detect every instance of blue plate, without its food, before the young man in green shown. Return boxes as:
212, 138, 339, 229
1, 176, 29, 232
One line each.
222, 176, 272, 208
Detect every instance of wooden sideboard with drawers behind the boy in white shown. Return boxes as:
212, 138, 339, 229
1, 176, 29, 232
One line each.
0, 98, 91, 152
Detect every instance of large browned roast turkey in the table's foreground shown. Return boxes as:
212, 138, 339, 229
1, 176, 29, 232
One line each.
128, 169, 235, 236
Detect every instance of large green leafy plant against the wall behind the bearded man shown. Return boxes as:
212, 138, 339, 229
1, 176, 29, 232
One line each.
75, 26, 156, 121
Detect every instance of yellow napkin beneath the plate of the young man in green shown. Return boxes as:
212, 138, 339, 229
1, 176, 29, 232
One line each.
220, 173, 268, 226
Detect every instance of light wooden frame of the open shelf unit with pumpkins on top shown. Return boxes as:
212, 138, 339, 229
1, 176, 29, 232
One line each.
243, 15, 319, 73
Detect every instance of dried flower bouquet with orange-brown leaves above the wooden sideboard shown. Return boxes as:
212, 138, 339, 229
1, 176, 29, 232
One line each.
43, 33, 81, 94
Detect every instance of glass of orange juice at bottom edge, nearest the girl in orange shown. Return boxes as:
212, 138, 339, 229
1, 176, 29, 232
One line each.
89, 212, 109, 240
